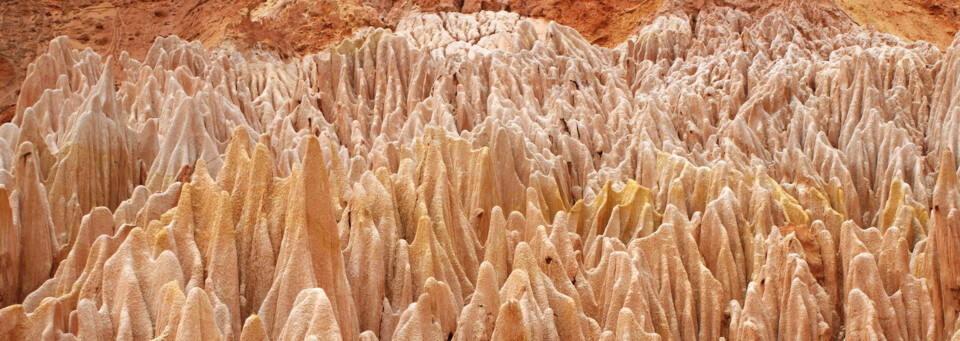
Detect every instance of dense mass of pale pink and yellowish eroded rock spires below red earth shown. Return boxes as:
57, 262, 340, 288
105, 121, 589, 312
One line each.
0, 4, 960, 340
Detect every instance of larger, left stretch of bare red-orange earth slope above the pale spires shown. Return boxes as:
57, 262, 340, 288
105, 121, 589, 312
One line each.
0, 0, 668, 124
